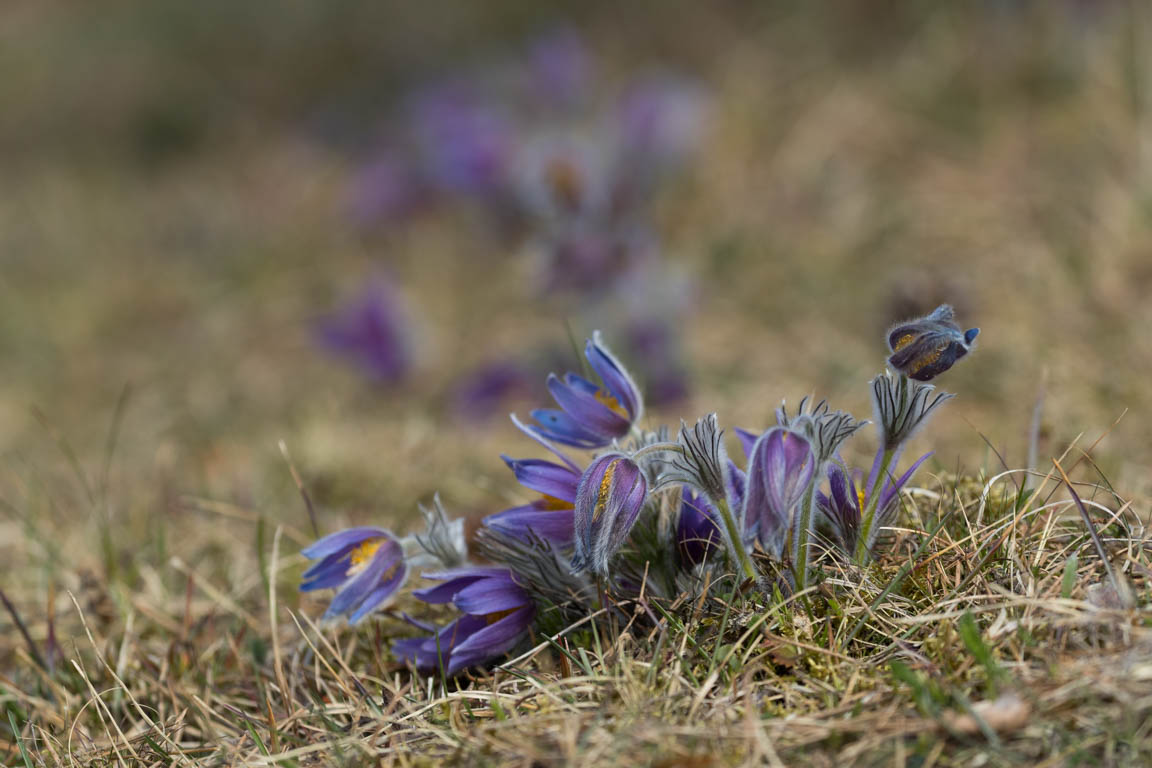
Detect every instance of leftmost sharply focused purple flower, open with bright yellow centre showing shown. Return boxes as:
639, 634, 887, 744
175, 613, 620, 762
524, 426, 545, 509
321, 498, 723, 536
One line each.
300, 527, 408, 624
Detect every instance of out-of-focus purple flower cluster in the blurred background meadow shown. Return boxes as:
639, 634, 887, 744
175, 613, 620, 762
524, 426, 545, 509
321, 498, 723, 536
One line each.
340, 29, 707, 414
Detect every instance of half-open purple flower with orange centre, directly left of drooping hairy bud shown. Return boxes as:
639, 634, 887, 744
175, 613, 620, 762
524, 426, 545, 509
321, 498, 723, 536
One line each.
484, 456, 581, 547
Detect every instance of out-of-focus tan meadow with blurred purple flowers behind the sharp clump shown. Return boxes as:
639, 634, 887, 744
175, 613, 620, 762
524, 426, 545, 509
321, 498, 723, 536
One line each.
0, 0, 1152, 604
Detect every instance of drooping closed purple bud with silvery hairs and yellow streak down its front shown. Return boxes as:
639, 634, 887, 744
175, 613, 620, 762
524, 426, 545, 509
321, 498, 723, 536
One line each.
571, 454, 647, 576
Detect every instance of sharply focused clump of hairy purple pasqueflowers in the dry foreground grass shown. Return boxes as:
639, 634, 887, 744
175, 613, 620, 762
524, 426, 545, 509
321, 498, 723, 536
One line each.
301, 306, 976, 676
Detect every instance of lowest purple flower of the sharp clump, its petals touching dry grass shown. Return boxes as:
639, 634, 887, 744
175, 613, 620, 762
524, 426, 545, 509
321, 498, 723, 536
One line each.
392, 567, 536, 677
